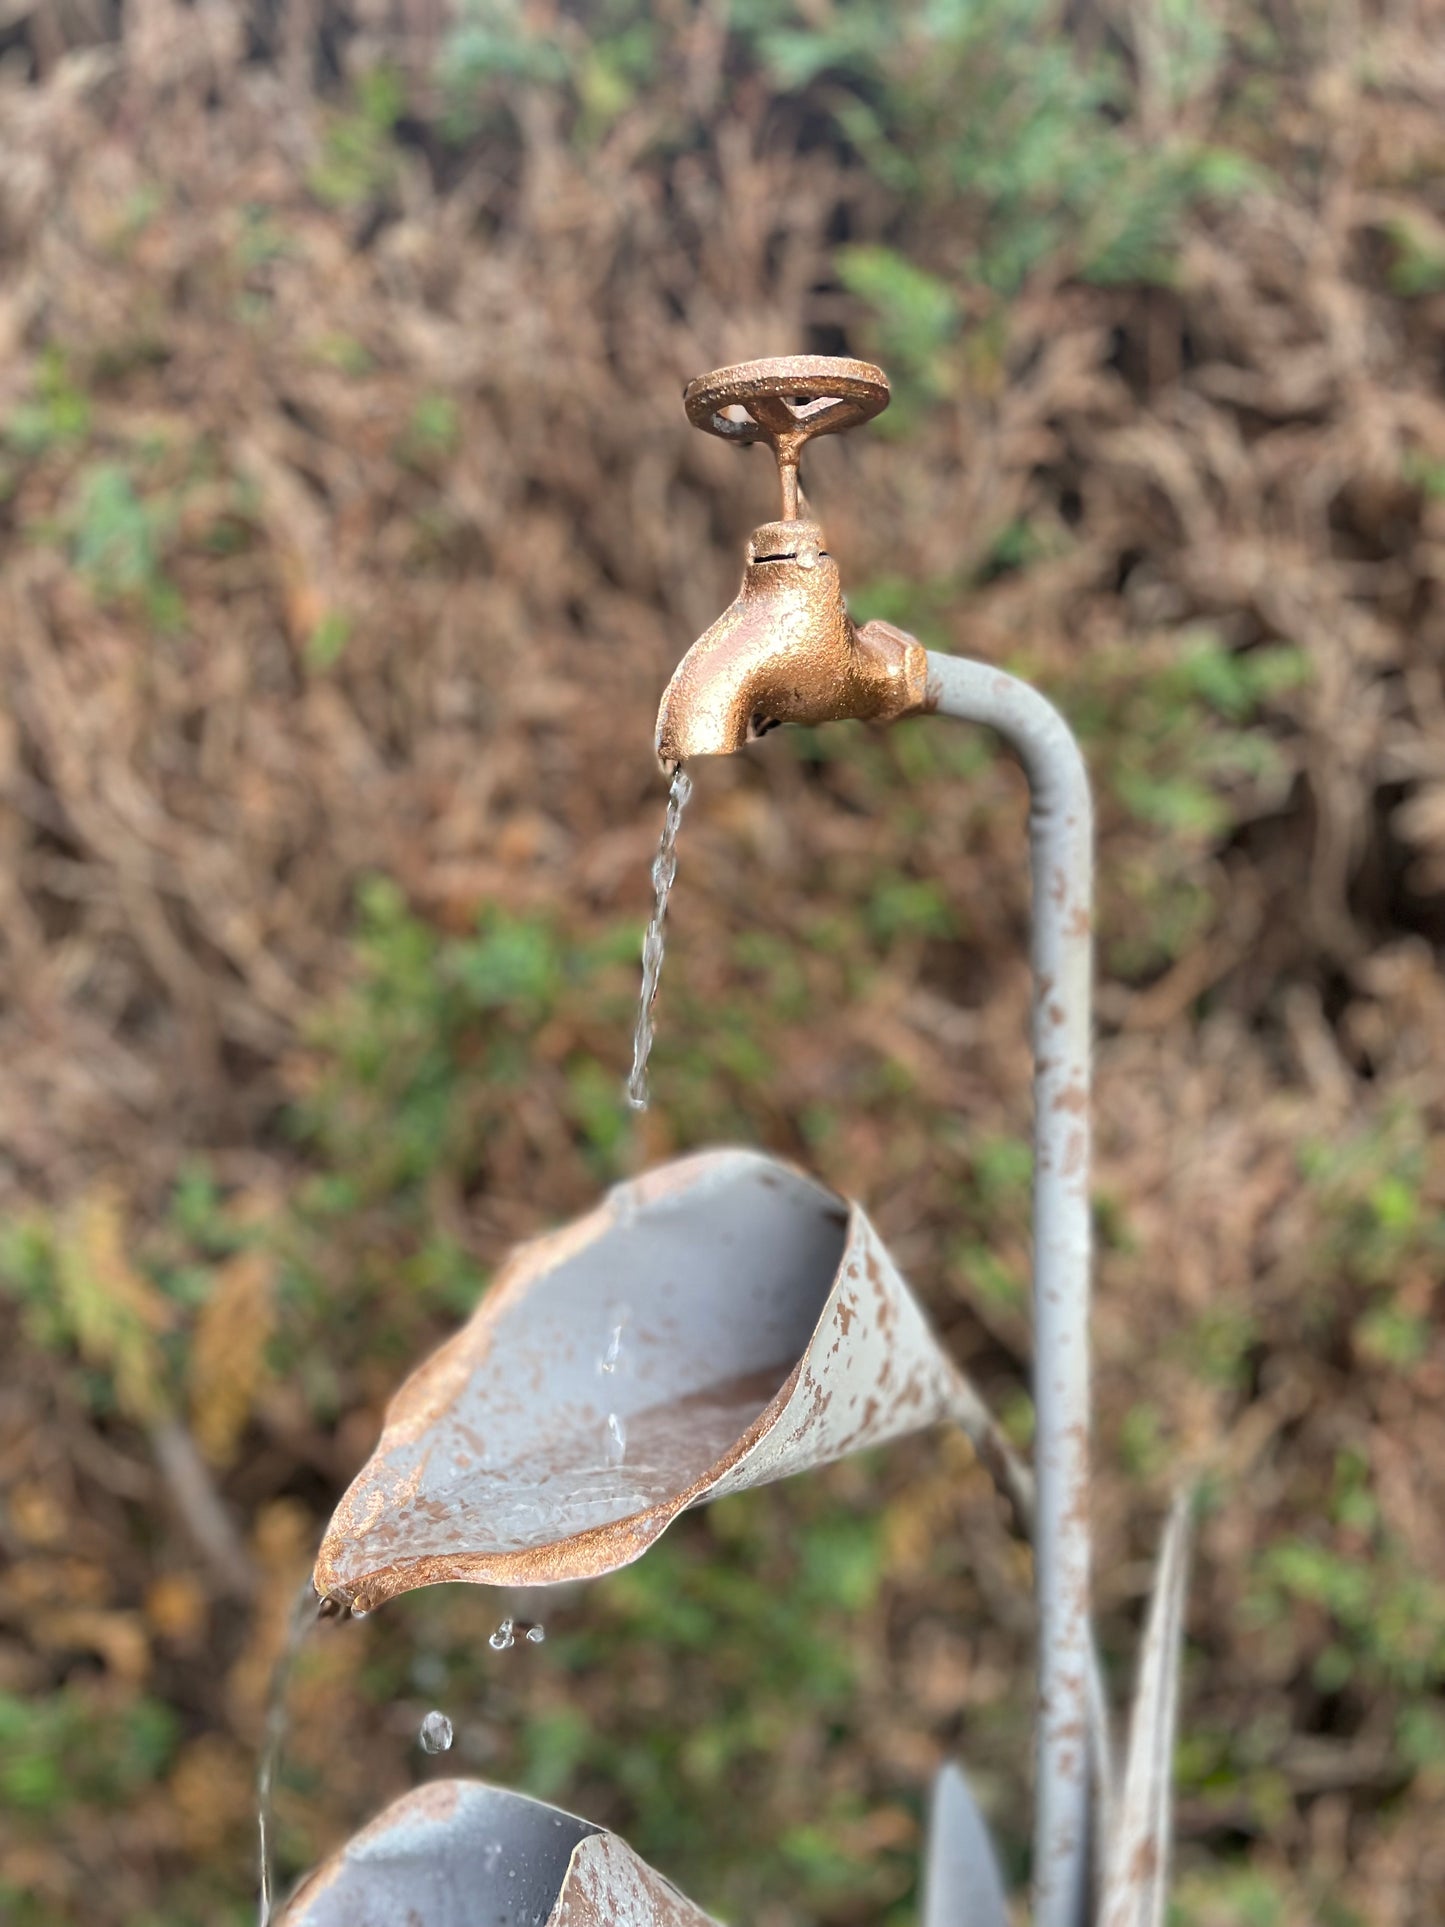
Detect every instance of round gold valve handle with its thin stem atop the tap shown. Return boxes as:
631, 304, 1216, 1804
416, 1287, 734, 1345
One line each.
682, 355, 888, 522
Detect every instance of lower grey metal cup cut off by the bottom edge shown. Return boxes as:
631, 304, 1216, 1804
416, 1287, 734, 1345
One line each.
276, 1781, 713, 1927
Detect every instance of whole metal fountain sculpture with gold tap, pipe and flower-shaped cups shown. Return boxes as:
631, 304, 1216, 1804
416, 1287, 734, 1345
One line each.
283, 356, 1187, 1927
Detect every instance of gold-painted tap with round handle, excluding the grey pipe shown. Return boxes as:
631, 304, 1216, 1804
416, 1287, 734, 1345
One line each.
657, 355, 927, 769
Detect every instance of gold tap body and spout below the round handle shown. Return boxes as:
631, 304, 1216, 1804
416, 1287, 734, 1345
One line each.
657, 520, 929, 767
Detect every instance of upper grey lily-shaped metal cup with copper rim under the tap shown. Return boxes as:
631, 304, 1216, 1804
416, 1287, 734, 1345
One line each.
316, 1150, 1009, 1611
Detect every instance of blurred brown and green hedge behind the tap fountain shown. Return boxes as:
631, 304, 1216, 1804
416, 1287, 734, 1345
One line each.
0, 0, 1445, 1927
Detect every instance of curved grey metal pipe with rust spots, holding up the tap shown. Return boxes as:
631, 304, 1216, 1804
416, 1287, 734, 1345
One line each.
929, 653, 1094, 1927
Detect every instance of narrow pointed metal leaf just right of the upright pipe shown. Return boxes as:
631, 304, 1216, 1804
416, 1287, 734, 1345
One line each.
1098, 1491, 1193, 1927
